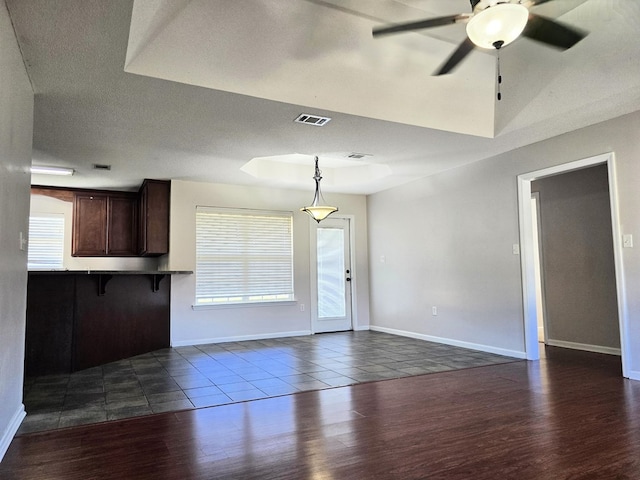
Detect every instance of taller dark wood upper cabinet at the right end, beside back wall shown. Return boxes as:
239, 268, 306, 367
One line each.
138, 179, 171, 256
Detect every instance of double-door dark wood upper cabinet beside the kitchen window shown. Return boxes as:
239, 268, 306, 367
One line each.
71, 193, 137, 257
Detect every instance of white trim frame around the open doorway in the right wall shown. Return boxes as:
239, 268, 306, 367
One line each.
518, 152, 631, 378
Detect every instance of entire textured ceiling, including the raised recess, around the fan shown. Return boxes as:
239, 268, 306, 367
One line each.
7, 0, 640, 193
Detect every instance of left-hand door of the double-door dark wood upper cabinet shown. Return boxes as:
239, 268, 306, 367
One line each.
71, 194, 107, 257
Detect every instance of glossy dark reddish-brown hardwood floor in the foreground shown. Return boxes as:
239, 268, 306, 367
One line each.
0, 348, 640, 480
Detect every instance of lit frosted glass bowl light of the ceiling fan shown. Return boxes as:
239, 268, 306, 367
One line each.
467, 3, 529, 49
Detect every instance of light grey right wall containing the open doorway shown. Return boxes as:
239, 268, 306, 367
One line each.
368, 112, 640, 368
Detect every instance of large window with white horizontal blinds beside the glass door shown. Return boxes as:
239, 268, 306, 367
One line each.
196, 206, 294, 306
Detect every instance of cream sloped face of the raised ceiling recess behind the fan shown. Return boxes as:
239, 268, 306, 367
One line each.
125, 0, 495, 137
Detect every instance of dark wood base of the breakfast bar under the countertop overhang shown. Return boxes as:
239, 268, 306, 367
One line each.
25, 272, 171, 377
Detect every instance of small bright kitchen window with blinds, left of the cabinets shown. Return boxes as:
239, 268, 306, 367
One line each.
27, 213, 64, 270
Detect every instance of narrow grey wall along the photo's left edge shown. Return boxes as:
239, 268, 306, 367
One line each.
0, 2, 33, 460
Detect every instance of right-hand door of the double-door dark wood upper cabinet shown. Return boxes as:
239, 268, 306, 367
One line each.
107, 196, 138, 256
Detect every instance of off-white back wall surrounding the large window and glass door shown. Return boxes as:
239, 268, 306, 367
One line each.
161, 180, 369, 346
